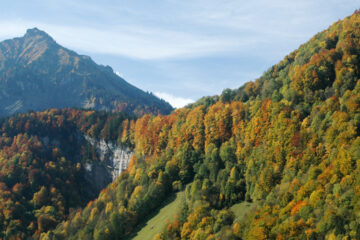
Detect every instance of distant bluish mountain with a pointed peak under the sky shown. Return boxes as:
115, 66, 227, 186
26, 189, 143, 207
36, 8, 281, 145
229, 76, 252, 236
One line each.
0, 28, 172, 116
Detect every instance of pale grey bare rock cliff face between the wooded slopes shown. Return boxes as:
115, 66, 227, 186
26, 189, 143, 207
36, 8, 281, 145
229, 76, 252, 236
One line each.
84, 136, 133, 187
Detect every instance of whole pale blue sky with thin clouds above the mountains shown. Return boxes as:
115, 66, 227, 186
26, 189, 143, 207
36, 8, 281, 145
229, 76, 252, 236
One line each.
0, 0, 360, 107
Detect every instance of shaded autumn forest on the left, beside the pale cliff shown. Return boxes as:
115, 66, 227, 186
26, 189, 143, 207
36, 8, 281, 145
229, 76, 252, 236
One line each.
0, 110, 134, 239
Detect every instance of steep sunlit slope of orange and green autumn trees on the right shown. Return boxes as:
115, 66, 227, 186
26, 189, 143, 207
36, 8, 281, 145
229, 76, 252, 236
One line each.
41, 12, 360, 240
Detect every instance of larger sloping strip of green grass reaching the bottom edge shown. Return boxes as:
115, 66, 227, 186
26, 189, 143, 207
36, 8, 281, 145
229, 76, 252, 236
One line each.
127, 191, 185, 240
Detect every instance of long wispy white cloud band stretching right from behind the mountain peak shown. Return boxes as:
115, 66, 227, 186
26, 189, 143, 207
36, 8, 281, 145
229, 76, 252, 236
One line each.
0, 20, 255, 60
